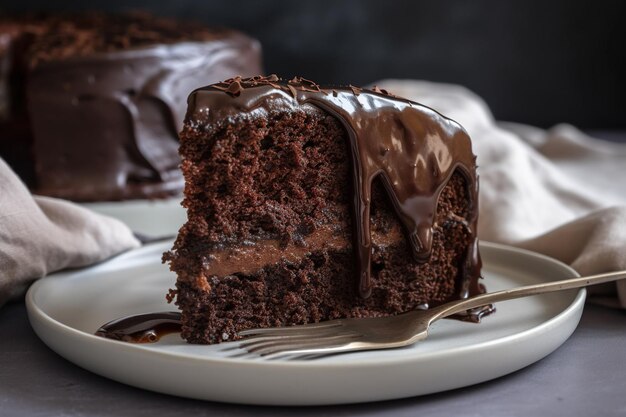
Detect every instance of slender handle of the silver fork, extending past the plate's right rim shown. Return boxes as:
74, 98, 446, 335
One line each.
431, 270, 626, 323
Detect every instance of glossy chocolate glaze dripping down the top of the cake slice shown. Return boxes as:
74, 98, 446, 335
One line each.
185, 75, 484, 298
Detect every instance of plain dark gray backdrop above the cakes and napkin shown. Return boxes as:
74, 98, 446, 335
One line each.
0, 0, 626, 128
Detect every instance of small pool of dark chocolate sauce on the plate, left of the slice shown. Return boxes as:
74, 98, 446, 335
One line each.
94, 311, 181, 343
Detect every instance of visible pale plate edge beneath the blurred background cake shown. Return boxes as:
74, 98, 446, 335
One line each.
81, 196, 187, 238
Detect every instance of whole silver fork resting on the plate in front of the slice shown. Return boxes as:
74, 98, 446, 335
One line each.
239, 271, 626, 356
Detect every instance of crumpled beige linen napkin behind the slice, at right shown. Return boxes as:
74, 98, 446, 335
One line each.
376, 80, 626, 308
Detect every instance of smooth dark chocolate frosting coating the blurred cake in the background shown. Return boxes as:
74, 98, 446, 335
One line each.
0, 17, 260, 201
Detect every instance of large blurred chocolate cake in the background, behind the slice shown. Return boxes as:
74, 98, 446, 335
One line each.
0, 13, 260, 201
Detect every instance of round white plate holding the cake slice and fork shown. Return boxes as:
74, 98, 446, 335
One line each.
26, 243, 585, 405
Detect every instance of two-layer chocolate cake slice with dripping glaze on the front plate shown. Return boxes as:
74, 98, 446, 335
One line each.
164, 76, 484, 343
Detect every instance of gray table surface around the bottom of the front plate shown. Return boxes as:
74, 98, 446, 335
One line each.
0, 131, 626, 417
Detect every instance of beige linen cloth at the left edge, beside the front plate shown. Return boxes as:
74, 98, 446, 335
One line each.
0, 159, 139, 306
